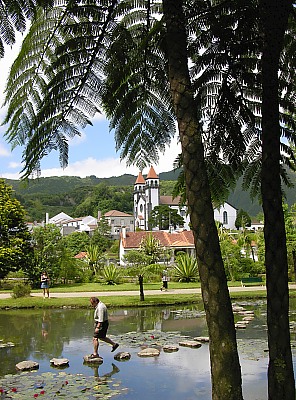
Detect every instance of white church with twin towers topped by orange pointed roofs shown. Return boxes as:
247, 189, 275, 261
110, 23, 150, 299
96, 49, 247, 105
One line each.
134, 166, 237, 231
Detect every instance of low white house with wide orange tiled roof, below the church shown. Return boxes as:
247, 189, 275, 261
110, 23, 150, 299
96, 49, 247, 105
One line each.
119, 229, 195, 266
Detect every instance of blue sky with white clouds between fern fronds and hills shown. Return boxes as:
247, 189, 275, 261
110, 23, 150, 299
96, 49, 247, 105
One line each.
0, 35, 181, 179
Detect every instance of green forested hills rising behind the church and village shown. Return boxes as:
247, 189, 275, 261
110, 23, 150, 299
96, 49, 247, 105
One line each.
6, 166, 296, 221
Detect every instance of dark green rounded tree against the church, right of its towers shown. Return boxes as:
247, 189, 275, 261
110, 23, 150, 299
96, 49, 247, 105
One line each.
148, 204, 184, 230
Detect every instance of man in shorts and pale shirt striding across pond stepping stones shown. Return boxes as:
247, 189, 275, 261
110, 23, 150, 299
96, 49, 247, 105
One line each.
90, 297, 119, 358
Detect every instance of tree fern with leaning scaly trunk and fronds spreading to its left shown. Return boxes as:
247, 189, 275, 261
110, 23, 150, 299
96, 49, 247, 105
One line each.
1, 0, 242, 400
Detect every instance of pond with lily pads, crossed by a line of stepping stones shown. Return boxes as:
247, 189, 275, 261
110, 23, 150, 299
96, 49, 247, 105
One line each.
0, 301, 296, 400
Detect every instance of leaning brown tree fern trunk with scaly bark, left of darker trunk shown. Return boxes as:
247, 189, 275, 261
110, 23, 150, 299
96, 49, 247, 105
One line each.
163, 0, 243, 400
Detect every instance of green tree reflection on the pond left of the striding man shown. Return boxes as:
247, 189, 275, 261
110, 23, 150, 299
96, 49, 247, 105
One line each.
0, 310, 89, 374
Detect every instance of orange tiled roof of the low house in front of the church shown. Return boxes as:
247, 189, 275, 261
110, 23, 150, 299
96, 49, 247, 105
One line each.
121, 231, 194, 249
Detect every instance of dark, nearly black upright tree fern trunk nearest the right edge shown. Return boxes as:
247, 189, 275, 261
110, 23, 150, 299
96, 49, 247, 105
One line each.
260, 0, 295, 400
